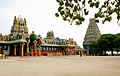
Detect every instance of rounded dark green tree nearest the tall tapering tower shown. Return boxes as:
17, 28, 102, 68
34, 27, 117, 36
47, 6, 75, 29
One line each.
93, 34, 116, 55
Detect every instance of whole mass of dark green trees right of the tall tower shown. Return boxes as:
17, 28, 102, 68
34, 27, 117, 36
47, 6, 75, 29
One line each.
90, 33, 120, 55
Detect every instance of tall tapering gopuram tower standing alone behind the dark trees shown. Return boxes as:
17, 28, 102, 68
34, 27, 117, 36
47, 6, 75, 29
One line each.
83, 18, 101, 55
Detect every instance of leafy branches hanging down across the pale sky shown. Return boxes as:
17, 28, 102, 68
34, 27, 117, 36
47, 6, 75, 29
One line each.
55, 0, 120, 25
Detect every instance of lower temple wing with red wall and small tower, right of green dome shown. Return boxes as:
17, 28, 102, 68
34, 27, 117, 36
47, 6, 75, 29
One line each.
41, 31, 82, 55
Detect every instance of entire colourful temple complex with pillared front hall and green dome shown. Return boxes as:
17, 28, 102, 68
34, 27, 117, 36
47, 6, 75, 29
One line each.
0, 16, 83, 56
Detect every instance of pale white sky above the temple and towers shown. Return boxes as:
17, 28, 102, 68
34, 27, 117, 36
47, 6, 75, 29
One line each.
0, 0, 120, 47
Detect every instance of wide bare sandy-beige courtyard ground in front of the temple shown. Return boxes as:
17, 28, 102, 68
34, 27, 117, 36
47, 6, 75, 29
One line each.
0, 56, 120, 76
